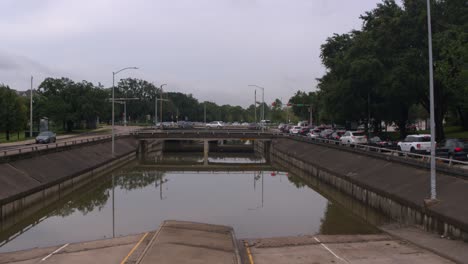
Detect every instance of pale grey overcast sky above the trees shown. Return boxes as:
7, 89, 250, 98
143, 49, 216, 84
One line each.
0, 0, 381, 107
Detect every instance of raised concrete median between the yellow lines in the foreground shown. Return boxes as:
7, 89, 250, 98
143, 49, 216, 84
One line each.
137, 220, 241, 264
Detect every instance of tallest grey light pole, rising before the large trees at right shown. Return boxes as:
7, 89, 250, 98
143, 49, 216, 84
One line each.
427, 0, 437, 200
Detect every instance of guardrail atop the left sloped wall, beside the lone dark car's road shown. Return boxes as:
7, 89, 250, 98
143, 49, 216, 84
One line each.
0, 131, 139, 157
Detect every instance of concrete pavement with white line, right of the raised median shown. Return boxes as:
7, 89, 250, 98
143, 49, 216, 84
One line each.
244, 235, 454, 264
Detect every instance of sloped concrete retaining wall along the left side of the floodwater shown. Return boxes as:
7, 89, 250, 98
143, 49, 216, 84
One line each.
0, 138, 137, 221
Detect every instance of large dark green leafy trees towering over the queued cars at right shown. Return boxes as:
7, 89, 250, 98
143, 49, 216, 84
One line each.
314, 0, 468, 140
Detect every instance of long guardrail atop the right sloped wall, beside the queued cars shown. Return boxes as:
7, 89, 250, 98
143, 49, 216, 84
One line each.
282, 133, 468, 170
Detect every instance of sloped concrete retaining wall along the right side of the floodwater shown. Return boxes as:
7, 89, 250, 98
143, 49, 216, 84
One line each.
270, 139, 468, 240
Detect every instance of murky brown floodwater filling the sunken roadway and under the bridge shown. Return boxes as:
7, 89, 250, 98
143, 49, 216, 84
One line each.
0, 153, 388, 252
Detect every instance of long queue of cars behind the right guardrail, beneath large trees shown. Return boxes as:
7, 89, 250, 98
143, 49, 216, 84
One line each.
278, 124, 468, 161
